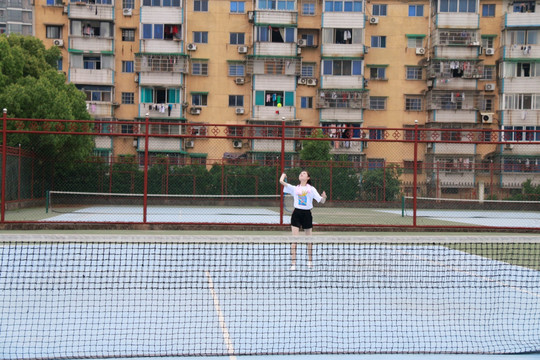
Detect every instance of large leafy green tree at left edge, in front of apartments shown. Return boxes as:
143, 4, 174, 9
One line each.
0, 34, 94, 167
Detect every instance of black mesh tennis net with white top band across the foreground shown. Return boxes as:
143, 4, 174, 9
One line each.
0, 235, 540, 359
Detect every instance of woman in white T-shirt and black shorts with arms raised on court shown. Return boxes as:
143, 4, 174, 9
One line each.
279, 171, 326, 270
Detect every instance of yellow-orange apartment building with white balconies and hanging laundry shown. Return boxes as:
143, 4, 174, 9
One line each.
32, 0, 540, 196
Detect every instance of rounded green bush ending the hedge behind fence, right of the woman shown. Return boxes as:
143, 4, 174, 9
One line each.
361, 165, 403, 201
